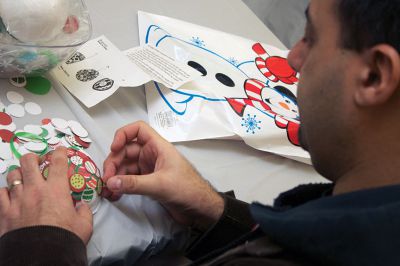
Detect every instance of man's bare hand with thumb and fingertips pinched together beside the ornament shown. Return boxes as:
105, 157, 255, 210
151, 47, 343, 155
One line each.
103, 122, 224, 229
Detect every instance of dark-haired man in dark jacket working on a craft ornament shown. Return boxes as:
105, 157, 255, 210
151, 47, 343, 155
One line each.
0, 0, 400, 265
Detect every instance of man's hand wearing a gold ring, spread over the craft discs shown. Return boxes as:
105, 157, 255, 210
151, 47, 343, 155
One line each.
0, 147, 92, 244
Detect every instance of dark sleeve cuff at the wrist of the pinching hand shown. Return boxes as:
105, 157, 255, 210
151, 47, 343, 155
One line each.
186, 193, 255, 260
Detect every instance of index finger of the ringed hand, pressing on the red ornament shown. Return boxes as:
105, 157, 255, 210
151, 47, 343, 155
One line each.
47, 147, 69, 188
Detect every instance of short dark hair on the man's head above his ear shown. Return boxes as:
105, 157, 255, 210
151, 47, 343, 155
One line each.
337, 0, 400, 52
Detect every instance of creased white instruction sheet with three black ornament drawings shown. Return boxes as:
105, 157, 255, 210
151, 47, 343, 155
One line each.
51, 36, 201, 107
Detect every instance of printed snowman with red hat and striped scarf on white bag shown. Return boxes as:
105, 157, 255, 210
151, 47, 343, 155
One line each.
145, 25, 300, 146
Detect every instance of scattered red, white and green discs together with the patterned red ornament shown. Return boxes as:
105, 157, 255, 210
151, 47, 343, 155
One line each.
0, 84, 103, 213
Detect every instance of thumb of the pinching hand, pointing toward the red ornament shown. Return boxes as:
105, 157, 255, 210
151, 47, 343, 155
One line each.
107, 173, 160, 196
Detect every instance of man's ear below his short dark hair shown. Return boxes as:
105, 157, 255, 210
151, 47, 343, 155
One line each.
354, 44, 400, 106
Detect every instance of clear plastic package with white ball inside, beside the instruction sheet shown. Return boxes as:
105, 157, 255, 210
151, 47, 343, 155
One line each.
0, 0, 91, 77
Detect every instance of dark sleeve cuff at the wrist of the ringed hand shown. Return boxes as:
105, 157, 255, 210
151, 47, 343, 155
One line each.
0, 226, 87, 266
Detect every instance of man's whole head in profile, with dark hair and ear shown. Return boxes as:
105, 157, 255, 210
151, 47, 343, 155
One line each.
289, 0, 400, 191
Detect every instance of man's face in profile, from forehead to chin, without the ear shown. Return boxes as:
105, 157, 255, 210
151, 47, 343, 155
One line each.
288, 0, 357, 179
